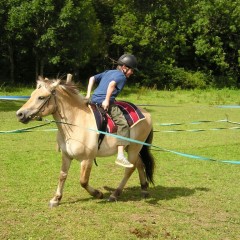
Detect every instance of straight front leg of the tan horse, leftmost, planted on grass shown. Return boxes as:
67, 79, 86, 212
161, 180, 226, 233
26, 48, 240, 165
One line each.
49, 152, 72, 207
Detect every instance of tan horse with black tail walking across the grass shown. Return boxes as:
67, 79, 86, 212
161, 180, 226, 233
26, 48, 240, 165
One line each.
16, 74, 155, 207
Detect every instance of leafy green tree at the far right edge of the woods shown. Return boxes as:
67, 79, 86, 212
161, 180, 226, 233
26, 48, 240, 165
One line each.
191, 0, 240, 86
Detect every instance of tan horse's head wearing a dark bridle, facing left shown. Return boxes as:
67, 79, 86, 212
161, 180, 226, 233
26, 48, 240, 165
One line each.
16, 77, 61, 123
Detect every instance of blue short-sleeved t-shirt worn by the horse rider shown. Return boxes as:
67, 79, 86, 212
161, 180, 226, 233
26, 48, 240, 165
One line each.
91, 70, 127, 104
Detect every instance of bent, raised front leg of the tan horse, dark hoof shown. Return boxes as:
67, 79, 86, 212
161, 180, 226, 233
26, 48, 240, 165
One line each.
80, 159, 103, 199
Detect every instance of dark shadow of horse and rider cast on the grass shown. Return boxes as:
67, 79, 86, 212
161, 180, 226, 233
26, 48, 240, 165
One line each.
61, 186, 210, 205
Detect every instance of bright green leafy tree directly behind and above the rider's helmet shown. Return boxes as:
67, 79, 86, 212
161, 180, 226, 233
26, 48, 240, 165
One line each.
112, 0, 193, 88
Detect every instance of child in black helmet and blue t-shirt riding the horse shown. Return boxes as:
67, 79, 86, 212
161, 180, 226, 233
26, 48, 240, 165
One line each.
86, 54, 137, 168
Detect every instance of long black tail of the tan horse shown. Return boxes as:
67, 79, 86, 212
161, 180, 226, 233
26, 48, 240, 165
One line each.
139, 129, 155, 184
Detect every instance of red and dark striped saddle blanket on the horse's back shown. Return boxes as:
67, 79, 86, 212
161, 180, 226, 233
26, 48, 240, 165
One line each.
89, 101, 145, 149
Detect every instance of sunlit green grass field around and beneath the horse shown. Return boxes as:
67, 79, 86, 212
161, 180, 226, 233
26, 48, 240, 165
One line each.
0, 88, 240, 240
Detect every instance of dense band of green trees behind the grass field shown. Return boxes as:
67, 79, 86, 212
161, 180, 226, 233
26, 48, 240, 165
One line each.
0, 0, 240, 89
